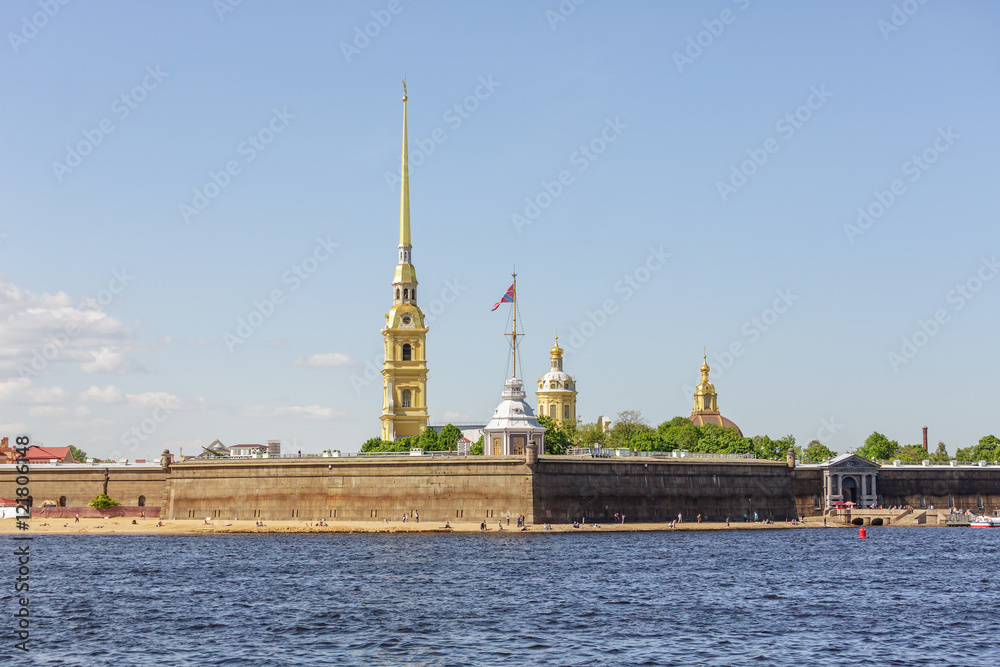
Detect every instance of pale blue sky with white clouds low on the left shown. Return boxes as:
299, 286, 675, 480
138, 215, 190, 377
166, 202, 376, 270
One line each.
0, 0, 1000, 458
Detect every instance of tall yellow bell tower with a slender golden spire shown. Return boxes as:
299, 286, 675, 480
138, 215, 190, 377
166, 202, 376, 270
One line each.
381, 80, 427, 440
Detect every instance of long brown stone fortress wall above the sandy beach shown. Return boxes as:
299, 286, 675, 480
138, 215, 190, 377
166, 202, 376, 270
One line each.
0, 456, 1000, 524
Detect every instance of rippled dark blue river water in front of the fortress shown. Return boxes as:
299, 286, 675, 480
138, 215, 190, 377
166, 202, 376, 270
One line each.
7, 528, 1000, 667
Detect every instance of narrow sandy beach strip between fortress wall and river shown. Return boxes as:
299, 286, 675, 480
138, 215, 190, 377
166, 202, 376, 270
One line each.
0, 517, 834, 535
